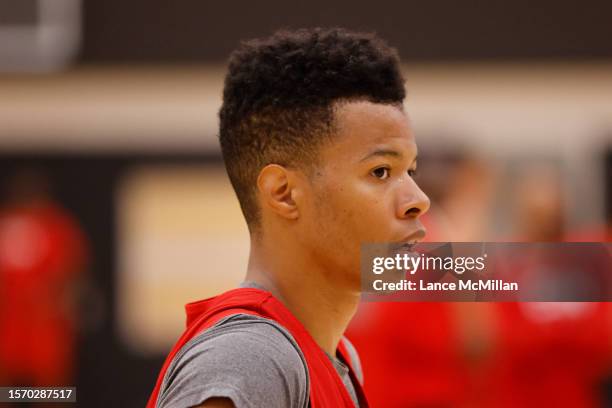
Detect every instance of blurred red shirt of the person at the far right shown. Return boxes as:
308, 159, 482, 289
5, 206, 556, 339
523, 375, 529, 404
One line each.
482, 229, 612, 408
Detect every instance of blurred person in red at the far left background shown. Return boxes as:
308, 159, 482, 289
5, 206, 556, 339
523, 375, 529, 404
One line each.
0, 169, 88, 386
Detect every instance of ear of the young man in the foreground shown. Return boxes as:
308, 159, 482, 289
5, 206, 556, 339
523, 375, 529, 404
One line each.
257, 164, 299, 220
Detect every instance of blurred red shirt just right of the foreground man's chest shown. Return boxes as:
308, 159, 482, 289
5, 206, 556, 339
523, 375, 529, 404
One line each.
347, 302, 469, 408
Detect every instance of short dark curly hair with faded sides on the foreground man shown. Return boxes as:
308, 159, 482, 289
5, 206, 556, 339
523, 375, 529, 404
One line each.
219, 28, 405, 231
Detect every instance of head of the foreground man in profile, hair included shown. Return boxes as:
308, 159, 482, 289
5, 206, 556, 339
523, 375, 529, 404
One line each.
219, 29, 429, 286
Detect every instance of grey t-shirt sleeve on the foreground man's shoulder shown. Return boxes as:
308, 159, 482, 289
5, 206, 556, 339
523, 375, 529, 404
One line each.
158, 318, 309, 408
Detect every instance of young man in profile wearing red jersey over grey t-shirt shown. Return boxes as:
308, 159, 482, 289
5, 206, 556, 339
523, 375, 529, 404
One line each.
149, 29, 429, 407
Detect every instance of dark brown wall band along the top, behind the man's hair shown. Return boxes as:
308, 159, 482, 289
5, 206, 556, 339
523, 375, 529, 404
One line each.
82, 0, 612, 62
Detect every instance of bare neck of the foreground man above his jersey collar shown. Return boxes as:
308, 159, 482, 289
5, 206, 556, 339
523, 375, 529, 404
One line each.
246, 237, 359, 356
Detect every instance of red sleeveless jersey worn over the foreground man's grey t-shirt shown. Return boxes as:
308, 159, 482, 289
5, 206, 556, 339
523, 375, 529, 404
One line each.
147, 288, 368, 408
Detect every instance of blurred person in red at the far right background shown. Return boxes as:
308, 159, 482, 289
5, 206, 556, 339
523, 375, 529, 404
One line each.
481, 164, 612, 407
